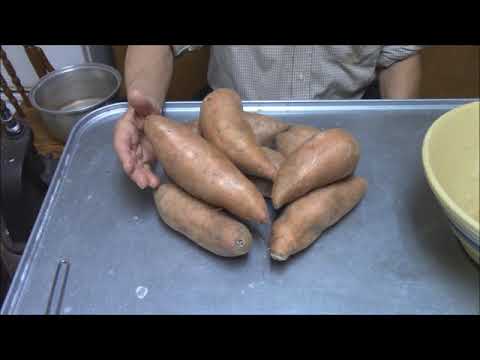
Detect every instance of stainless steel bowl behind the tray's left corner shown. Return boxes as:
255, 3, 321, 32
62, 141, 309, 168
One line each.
30, 63, 122, 142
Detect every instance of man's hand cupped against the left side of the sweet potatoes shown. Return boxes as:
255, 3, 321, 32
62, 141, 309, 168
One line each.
113, 90, 160, 189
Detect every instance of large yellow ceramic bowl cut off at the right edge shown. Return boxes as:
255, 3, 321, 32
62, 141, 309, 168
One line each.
422, 102, 480, 263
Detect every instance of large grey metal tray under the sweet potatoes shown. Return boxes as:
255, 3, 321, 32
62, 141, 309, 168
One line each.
1, 99, 480, 314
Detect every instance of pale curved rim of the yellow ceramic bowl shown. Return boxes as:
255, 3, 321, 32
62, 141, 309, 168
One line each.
422, 101, 480, 236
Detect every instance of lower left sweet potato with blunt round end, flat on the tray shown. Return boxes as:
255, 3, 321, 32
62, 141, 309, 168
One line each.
154, 184, 252, 257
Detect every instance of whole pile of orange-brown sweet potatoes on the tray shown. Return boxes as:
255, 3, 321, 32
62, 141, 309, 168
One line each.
144, 89, 367, 261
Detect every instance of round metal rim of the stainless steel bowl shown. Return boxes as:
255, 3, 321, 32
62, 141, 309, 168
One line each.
29, 62, 122, 115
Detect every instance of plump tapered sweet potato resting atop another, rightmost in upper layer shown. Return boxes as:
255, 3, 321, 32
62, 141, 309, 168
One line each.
272, 129, 360, 209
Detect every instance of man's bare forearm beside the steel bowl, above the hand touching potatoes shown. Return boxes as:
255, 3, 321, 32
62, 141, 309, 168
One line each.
125, 45, 173, 105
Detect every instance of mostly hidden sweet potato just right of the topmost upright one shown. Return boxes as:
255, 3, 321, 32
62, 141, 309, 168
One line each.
243, 111, 290, 146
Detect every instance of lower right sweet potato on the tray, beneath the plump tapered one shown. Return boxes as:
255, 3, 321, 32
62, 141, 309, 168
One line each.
270, 177, 367, 261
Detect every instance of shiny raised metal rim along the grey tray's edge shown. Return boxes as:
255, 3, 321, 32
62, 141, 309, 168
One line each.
0, 98, 480, 315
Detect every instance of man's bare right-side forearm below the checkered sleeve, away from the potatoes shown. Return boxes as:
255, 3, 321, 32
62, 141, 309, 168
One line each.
379, 53, 421, 99
